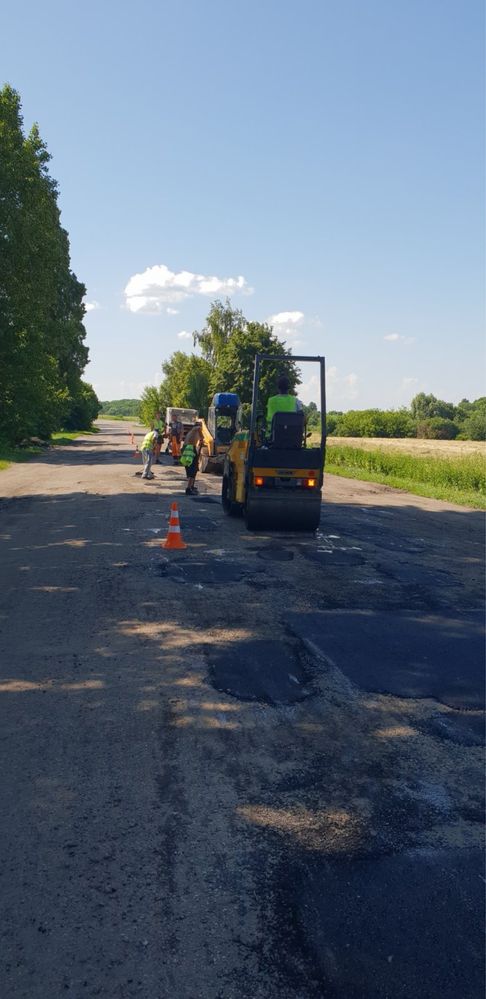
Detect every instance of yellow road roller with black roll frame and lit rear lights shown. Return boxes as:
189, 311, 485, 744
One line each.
221, 354, 326, 531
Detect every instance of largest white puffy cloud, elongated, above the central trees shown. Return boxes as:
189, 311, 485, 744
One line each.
125, 264, 252, 315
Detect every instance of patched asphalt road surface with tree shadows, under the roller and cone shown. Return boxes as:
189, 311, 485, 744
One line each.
0, 421, 485, 999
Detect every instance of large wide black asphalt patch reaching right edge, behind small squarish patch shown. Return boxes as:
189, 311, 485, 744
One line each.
287, 610, 484, 710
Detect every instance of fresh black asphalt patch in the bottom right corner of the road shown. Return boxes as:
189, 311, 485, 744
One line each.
287, 849, 484, 999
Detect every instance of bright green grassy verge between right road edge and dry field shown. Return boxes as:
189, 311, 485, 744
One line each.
326, 445, 486, 510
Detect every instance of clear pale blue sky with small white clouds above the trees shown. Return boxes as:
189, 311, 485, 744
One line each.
2, 0, 486, 409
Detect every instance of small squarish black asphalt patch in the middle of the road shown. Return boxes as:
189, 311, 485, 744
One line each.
207, 640, 312, 705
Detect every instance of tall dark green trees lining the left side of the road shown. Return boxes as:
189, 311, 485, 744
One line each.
0, 85, 99, 444
